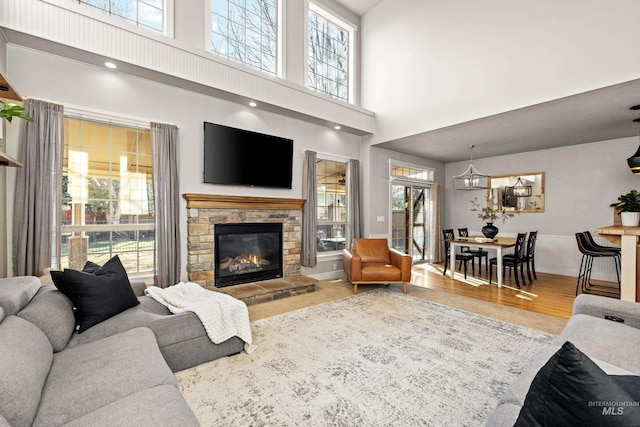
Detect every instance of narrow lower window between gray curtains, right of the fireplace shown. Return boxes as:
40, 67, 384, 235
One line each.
316, 159, 347, 252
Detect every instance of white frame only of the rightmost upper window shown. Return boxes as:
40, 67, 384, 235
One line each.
304, 1, 358, 104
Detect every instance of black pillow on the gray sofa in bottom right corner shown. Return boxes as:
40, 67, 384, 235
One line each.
514, 341, 640, 427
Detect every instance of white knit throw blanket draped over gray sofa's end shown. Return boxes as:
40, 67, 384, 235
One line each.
145, 282, 256, 353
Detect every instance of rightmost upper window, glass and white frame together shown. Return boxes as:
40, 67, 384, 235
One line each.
308, 3, 355, 101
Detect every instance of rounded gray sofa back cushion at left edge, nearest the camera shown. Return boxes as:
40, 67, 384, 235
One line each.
0, 316, 53, 427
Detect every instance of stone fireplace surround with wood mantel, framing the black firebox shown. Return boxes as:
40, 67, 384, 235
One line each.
183, 194, 303, 290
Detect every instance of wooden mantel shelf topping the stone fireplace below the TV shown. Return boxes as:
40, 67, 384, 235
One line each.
182, 193, 304, 210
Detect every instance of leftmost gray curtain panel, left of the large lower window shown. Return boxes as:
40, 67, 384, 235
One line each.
13, 99, 64, 276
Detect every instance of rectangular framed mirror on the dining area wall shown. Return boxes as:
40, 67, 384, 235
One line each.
487, 172, 544, 213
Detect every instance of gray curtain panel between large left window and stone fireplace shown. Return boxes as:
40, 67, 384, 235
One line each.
151, 123, 181, 288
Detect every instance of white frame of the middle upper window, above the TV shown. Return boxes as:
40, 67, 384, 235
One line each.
204, 0, 285, 78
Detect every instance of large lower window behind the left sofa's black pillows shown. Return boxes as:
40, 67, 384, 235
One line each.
59, 116, 155, 274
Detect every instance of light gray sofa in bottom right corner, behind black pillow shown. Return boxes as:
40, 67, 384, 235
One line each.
486, 294, 640, 427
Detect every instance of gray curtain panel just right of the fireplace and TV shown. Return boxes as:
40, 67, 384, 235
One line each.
300, 150, 318, 267
